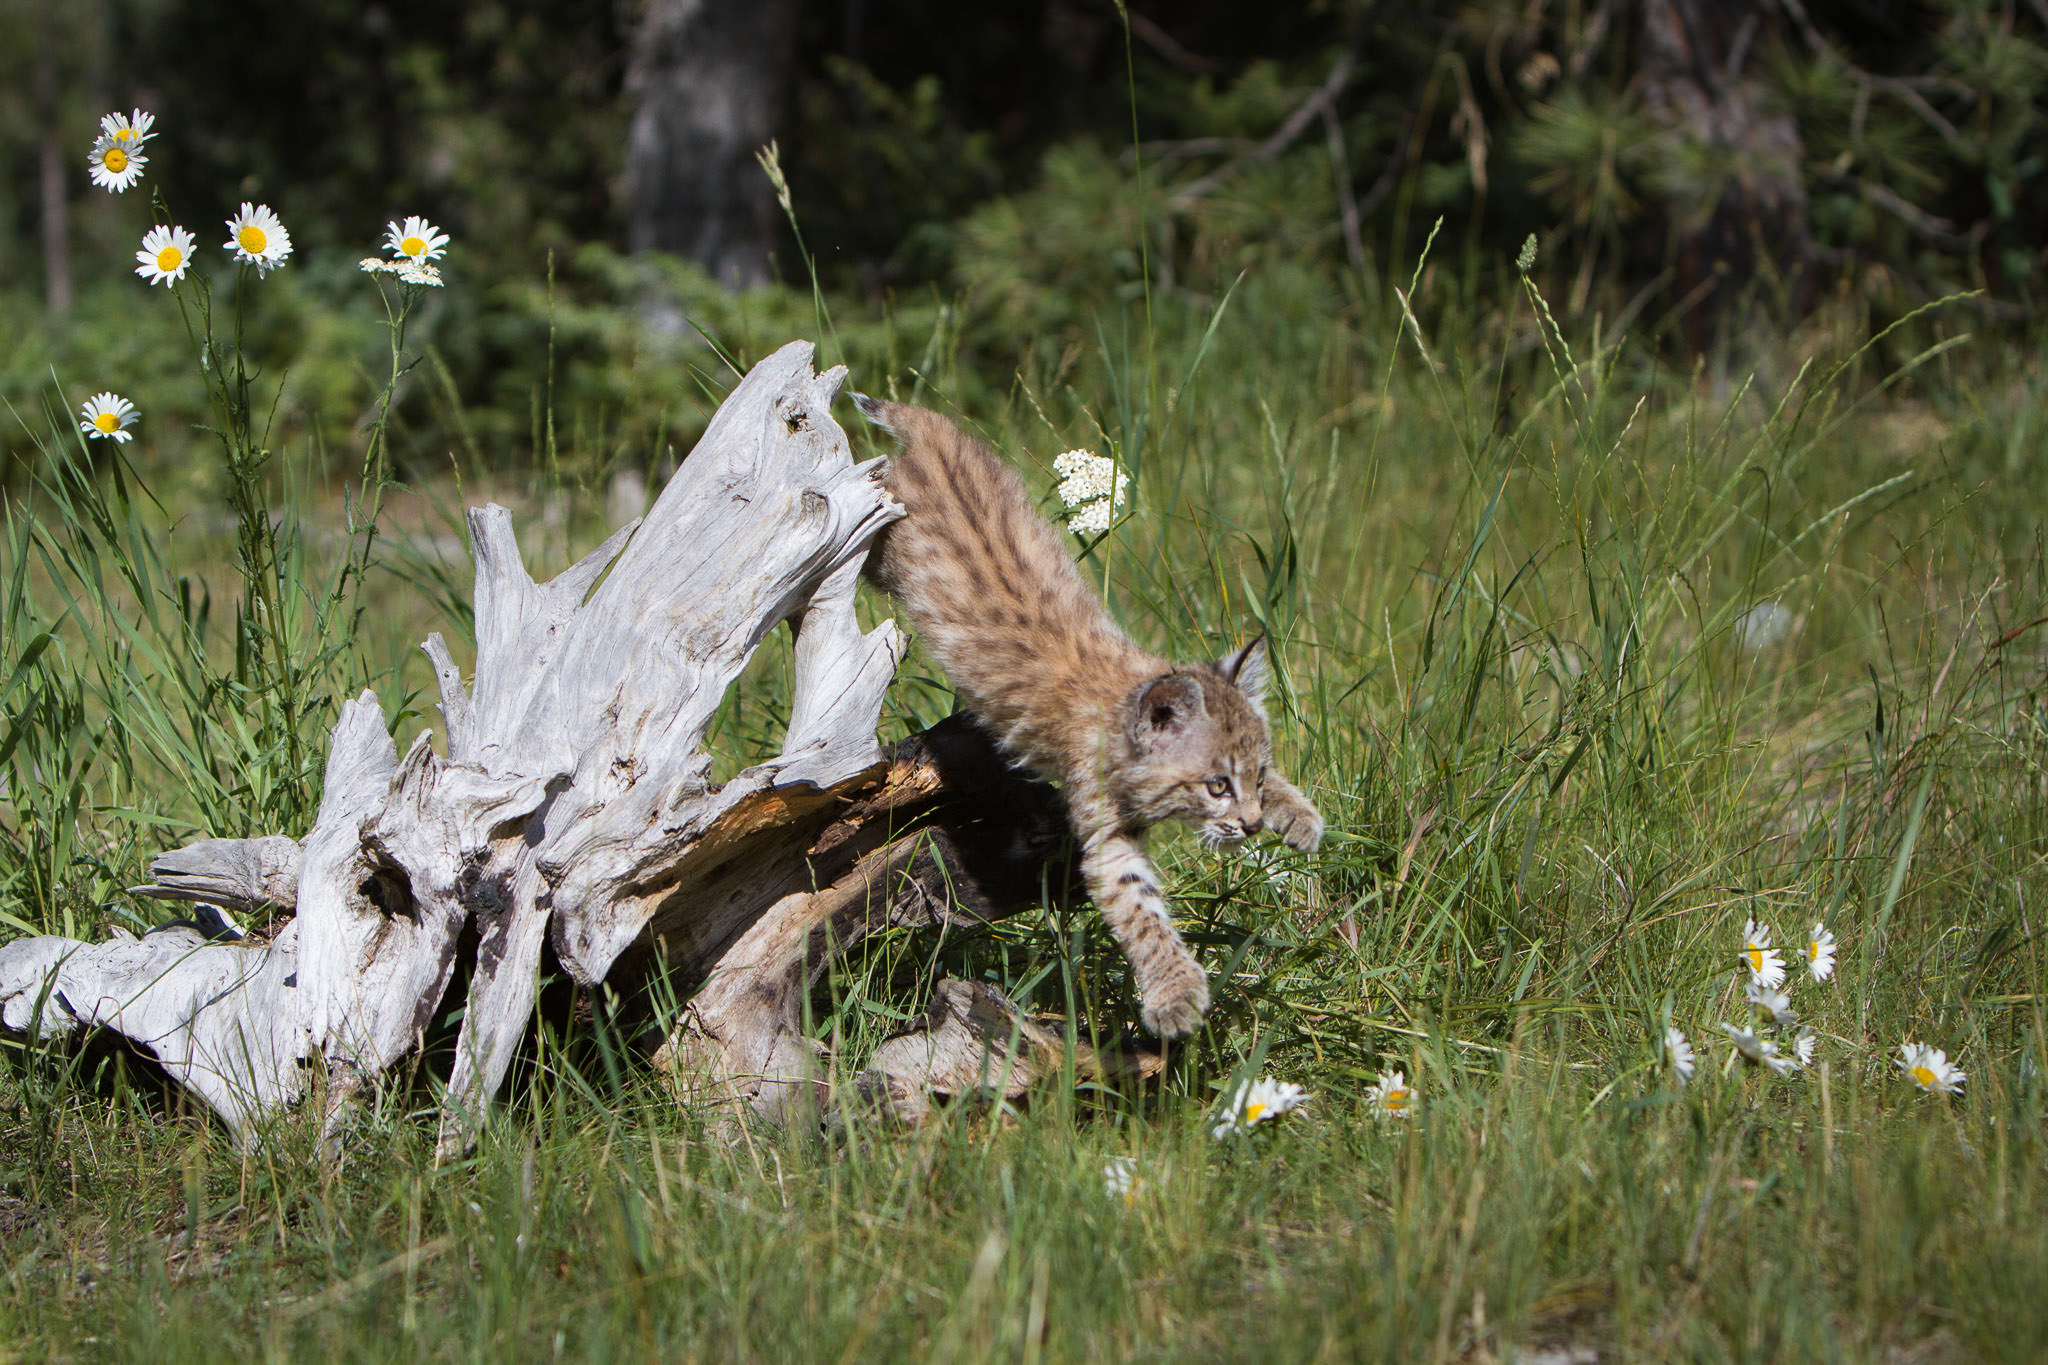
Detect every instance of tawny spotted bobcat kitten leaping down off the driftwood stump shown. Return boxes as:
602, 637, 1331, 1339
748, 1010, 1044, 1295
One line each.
854, 393, 1323, 1038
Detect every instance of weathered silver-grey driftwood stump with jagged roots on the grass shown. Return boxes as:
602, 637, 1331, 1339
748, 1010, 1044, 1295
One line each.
0, 342, 1089, 1150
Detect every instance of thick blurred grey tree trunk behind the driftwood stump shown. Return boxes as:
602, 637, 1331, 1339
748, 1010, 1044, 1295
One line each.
625, 0, 797, 289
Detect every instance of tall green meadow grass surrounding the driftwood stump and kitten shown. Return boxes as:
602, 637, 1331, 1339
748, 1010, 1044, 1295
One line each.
0, 253, 2048, 1361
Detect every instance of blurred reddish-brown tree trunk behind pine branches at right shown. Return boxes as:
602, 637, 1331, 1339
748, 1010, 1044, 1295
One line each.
1636, 0, 1812, 342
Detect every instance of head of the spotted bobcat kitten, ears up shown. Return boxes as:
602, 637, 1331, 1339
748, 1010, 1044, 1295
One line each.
1110, 636, 1272, 847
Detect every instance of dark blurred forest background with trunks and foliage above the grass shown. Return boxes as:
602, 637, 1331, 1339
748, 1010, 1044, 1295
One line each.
0, 0, 2048, 475
